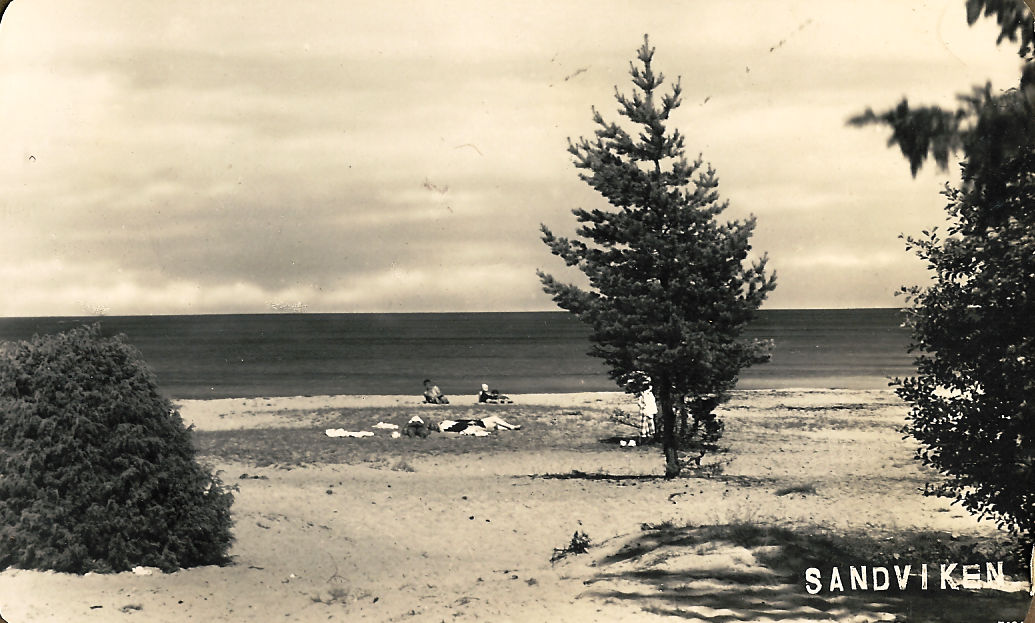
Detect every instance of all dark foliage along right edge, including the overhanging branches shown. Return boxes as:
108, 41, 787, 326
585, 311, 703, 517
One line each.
849, 0, 1035, 558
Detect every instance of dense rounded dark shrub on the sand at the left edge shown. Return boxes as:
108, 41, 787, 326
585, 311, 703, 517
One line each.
0, 325, 233, 573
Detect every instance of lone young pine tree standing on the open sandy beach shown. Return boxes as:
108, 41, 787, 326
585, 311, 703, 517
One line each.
537, 36, 776, 477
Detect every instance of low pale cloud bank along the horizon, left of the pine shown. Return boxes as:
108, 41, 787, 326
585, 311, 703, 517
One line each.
0, 252, 558, 317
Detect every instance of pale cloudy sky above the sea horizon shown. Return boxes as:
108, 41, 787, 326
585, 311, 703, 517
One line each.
0, 0, 1021, 310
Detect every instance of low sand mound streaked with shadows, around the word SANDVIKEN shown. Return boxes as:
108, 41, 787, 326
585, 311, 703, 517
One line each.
580, 524, 1030, 623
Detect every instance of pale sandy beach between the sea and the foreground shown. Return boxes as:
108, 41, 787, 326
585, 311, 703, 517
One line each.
0, 389, 1028, 623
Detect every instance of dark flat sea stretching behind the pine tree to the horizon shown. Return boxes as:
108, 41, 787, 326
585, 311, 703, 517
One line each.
0, 308, 915, 399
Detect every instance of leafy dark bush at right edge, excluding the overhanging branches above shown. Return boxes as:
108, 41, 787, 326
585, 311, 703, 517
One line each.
896, 149, 1035, 540
